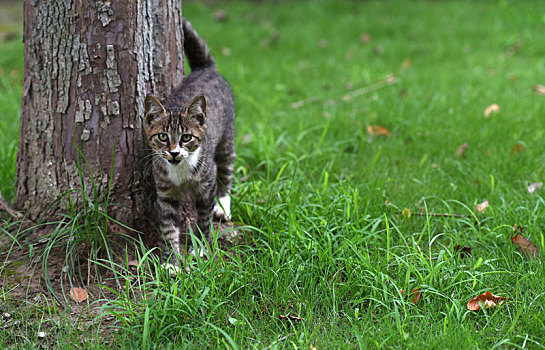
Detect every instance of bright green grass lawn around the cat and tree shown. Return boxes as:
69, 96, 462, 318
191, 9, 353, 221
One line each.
0, 1, 545, 349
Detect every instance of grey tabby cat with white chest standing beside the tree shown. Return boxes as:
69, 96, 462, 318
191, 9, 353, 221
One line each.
143, 19, 235, 266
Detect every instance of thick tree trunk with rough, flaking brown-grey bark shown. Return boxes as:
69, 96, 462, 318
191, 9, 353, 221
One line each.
15, 0, 184, 225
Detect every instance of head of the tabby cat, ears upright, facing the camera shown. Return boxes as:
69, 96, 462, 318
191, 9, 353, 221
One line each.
144, 95, 206, 165
